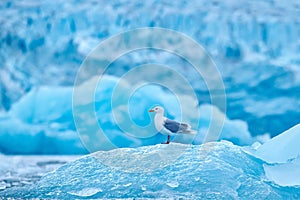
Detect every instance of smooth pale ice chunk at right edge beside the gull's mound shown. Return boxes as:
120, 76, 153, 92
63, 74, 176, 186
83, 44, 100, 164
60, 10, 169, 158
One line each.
253, 124, 300, 187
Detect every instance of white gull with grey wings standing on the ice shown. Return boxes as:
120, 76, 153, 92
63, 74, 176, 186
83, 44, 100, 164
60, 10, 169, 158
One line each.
149, 106, 196, 144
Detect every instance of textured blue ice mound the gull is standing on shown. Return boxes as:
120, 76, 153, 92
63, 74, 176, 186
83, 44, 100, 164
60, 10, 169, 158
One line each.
0, 141, 300, 199
